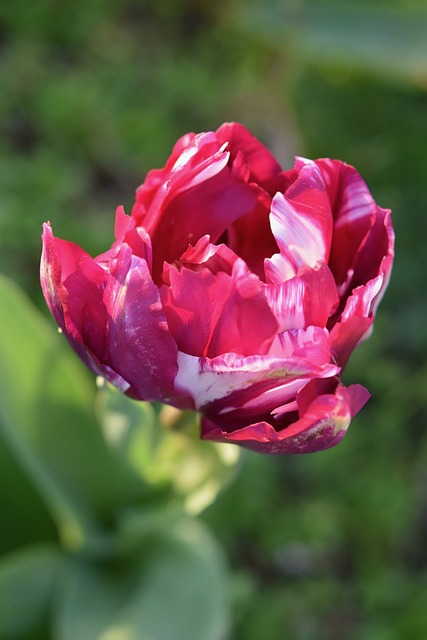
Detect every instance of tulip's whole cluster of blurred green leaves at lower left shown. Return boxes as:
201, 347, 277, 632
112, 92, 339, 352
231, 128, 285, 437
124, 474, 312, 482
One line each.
0, 278, 231, 640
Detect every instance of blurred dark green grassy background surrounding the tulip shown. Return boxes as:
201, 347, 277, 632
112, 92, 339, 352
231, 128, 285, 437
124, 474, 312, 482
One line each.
0, 0, 427, 640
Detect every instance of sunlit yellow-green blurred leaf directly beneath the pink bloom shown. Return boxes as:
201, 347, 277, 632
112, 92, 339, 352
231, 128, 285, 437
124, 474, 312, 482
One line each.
97, 385, 239, 515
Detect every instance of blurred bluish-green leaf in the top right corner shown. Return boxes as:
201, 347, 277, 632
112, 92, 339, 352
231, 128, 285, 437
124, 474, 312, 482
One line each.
233, 0, 427, 87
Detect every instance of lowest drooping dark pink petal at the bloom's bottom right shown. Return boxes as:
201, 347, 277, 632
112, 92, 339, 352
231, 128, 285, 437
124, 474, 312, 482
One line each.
202, 385, 369, 454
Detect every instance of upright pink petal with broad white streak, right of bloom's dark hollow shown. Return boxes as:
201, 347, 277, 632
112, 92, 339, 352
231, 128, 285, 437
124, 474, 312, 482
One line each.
265, 159, 332, 282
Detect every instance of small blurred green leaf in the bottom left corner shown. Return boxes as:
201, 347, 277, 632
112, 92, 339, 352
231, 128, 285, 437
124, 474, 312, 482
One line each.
0, 546, 63, 640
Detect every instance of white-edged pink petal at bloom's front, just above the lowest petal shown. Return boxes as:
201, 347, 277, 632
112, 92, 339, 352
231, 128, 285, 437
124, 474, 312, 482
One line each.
175, 327, 339, 424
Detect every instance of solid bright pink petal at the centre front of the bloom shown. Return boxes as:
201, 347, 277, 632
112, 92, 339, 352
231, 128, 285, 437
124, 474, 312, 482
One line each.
161, 260, 277, 357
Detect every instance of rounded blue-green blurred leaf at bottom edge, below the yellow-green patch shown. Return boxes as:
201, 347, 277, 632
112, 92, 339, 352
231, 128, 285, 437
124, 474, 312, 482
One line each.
55, 520, 232, 640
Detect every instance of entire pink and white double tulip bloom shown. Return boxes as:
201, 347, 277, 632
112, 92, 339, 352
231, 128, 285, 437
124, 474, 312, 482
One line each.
41, 123, 394, 453
